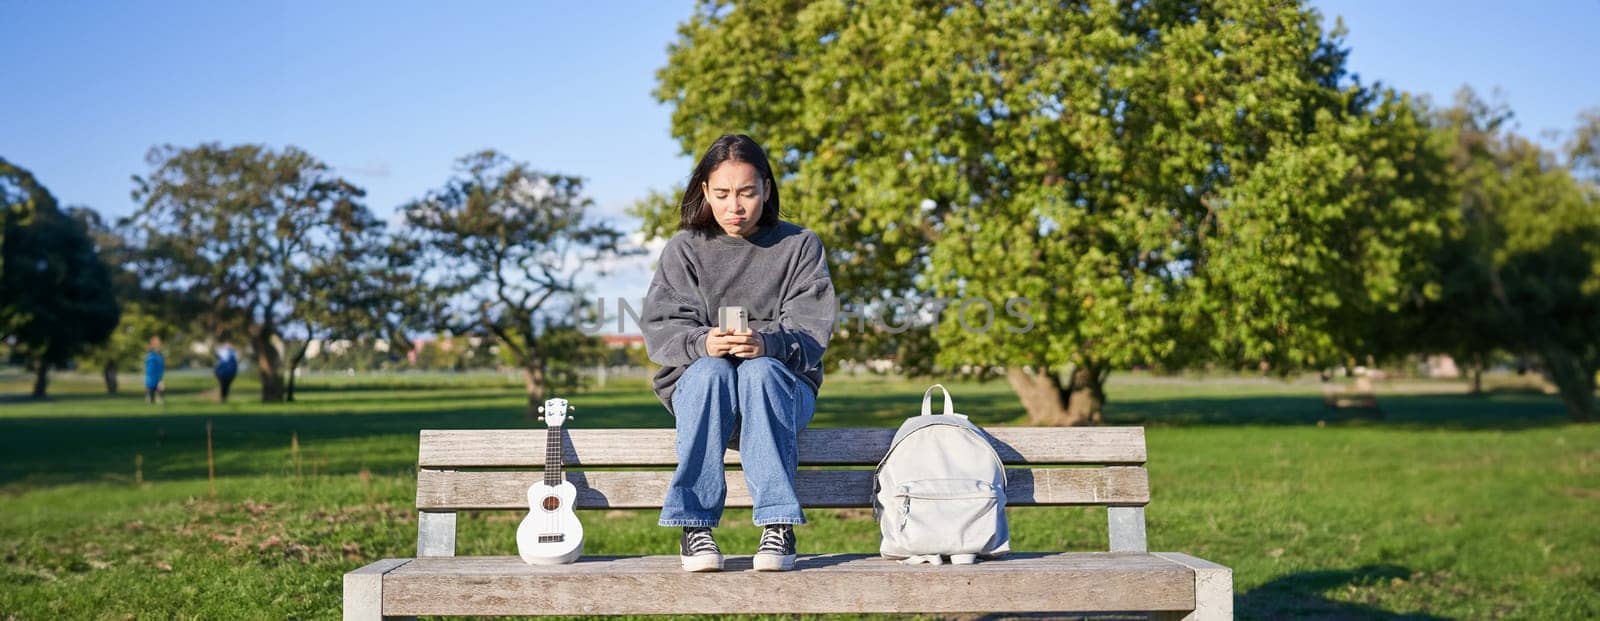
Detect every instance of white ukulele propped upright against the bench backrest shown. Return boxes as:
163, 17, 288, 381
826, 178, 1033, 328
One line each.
517, 399, 584, 565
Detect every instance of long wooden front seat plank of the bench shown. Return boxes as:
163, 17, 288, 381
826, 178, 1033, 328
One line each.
382, 552, 1195, 615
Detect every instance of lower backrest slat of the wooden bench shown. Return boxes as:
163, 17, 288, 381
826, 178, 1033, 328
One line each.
416, 466, 1150, 511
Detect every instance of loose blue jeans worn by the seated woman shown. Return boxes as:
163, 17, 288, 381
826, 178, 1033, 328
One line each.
661, 357, 816, 527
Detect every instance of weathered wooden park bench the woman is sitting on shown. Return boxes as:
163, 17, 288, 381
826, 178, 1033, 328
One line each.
344, 427, 1234, 619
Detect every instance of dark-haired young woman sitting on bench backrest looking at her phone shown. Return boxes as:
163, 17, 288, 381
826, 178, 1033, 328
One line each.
640, 134, 838, 571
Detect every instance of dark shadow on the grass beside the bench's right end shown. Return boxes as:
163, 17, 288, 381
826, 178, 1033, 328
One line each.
1234, 565, 1446, 621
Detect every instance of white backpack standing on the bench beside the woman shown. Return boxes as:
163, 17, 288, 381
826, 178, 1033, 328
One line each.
872, 384, 1011, 565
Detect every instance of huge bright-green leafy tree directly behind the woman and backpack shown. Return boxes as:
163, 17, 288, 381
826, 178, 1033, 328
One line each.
640, 0, 1448, 424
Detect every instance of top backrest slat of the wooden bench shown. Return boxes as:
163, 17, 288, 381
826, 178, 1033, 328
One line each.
418, 427, 1146, 467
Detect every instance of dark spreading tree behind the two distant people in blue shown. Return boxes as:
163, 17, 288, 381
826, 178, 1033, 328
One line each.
131, 142, 378, 402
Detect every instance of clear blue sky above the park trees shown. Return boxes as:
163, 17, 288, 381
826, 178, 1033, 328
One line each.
0, 0, 1600, 310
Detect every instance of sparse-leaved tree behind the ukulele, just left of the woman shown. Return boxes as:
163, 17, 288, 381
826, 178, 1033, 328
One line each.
405, 150, 637, 411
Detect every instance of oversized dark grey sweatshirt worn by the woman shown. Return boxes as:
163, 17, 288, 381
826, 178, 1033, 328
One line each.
640, 221, 838, 411
